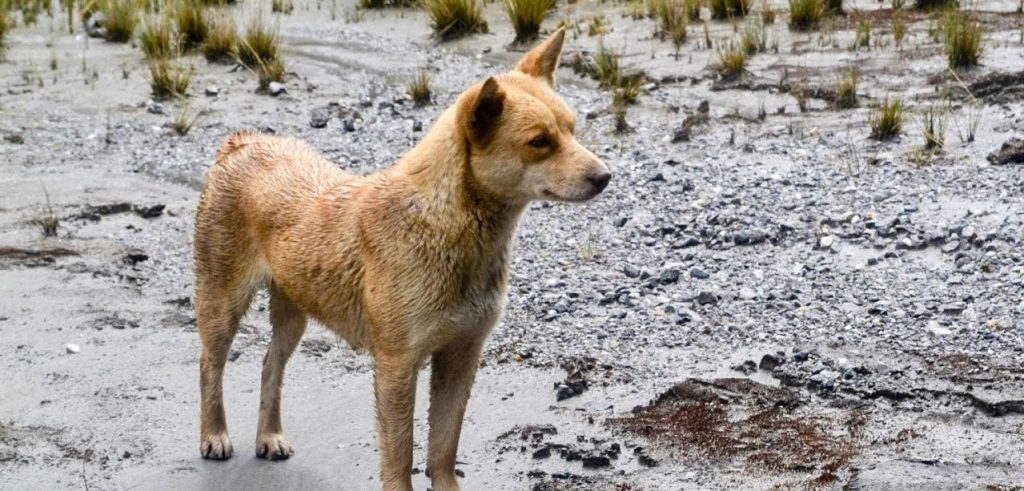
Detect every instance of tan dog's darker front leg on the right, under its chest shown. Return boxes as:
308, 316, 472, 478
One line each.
427, 336, 483, 491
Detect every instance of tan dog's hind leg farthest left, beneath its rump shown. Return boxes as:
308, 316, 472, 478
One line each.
196, 279, 252, 460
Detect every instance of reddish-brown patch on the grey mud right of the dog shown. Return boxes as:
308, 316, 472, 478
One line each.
607, 378, 867, 486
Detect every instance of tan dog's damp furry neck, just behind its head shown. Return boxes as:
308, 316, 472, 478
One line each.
393, 109, 527, 246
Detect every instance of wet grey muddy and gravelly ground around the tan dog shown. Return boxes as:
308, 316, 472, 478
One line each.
0, 0, 1024, 490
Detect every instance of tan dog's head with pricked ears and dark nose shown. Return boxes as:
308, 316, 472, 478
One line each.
458, 30, 611, 206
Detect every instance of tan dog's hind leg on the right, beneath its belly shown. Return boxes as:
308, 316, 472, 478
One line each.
256, 285, 306, 460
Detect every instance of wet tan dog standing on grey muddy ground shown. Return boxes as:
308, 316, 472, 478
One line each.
196, 31, 610, 490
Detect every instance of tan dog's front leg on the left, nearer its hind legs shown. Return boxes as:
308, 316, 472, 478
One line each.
374, 355, 419, 491
